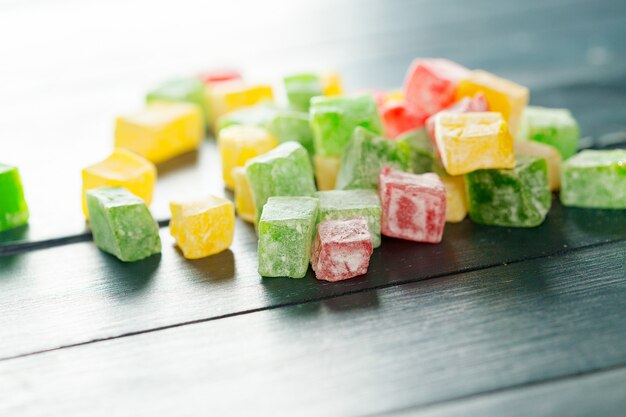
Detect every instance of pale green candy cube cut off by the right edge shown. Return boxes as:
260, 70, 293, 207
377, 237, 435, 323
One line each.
561, 150, 626, 209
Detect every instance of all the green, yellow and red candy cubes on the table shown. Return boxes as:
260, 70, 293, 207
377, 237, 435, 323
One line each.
0, 59, 626, 281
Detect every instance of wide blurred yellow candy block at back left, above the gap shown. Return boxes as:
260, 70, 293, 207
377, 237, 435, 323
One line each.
115, 102, 204, 163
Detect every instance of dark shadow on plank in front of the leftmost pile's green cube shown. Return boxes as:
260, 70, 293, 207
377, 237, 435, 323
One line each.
98, 251, 161, 297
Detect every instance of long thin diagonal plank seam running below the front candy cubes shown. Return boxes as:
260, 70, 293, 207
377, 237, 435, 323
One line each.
0, 238, 626, 362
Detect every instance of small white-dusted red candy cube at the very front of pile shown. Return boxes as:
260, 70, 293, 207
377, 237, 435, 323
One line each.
311, 217, 372, 282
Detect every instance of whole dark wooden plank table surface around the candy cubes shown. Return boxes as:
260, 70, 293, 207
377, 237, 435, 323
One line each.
0, 0, 626, 416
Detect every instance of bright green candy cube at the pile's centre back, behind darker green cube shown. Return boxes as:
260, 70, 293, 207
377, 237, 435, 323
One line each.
310, 95, 383, 156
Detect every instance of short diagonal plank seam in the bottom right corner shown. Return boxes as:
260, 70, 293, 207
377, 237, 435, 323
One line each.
359, 363, 626, 417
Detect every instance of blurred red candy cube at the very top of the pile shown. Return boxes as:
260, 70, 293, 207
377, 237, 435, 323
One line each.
404, 58, 470, 116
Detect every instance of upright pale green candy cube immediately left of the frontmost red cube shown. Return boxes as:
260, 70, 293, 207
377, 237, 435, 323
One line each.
258, 197, 319, 278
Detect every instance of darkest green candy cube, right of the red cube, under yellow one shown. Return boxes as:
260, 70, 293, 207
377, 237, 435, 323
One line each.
465, 156, 552, 227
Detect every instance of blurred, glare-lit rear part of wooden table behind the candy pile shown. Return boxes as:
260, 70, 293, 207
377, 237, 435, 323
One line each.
0, 0, 626, 246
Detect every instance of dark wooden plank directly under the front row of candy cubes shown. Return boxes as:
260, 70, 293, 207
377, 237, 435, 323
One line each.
0, 198, 626, 358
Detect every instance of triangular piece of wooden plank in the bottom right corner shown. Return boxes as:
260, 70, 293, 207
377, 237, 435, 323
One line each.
385, 366, 626, 417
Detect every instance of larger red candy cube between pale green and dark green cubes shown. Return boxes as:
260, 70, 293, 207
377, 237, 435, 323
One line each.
378, 167, 446, 243
